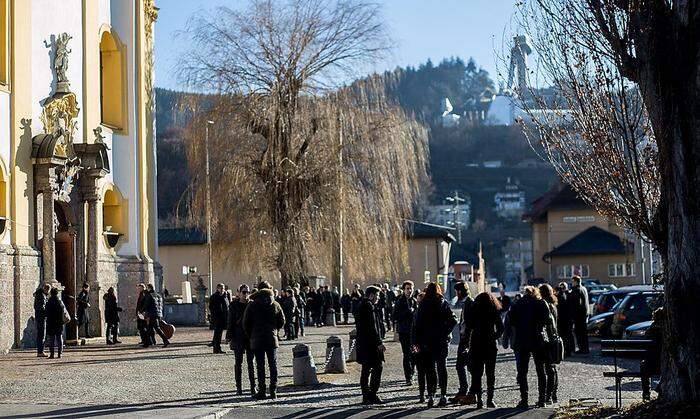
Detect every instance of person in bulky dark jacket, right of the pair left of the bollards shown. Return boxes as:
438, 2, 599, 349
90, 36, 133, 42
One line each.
243, 281, 285, 400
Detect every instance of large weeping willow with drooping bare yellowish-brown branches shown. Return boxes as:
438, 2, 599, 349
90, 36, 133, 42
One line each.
181, 0, 427, 285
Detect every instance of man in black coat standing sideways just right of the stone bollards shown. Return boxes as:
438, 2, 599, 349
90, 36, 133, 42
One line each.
355, 285, 386, 405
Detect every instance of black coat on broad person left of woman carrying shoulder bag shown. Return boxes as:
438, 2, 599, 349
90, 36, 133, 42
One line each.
508, 295, 550, 352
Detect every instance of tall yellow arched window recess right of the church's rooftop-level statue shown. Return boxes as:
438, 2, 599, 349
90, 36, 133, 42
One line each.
100, 31, 126, 130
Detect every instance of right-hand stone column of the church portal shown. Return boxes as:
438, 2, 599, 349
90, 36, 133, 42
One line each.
78, 169, 105, 336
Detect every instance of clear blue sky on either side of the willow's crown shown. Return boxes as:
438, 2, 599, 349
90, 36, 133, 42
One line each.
156, 0, 515, 90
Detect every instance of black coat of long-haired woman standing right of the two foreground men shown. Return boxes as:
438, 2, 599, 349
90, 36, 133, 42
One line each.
411, 295, 457, 358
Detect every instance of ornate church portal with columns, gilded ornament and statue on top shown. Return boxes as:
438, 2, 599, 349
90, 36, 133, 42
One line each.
32, 33, 110, 342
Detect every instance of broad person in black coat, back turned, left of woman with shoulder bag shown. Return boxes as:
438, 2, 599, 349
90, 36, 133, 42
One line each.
508, 285, 549, 408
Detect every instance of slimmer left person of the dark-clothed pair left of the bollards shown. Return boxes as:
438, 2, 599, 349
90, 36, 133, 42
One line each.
226, 284, 256, 396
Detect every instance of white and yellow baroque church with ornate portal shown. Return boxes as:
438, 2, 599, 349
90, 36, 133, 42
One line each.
0, 0, 160, 352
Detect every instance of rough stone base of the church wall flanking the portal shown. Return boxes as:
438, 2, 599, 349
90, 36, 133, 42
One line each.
0, 245, 162, 353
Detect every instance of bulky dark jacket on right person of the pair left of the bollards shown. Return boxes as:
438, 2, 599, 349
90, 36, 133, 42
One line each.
243, 289, 285, 351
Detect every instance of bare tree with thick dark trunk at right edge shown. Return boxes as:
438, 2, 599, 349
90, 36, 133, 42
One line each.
518, 0, 700, 401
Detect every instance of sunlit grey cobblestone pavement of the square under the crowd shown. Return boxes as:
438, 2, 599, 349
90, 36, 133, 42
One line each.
0, 325, 641, 417
